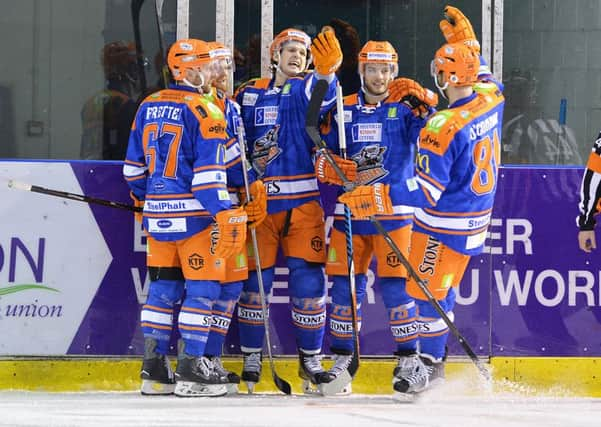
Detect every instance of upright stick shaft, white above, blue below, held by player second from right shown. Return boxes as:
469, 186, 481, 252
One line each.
336, 83, 360, 368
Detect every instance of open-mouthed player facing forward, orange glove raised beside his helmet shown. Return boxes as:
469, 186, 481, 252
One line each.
236, 28, 342, 389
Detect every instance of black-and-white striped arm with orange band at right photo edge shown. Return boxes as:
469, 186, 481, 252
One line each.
576, 132, 601, 252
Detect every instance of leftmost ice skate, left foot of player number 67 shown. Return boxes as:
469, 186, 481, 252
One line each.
140, 338, 175, 395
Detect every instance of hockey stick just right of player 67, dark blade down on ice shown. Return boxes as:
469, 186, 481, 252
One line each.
238, 124, 292, 394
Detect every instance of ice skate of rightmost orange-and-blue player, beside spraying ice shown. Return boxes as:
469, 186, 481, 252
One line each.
393, 355, 444, 400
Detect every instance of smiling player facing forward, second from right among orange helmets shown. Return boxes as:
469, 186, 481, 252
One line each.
315, 41, 438, 392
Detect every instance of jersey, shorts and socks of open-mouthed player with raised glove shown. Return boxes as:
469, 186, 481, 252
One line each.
236, 73, 336, 360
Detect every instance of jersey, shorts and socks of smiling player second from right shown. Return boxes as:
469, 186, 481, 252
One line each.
321, 88, 426, 354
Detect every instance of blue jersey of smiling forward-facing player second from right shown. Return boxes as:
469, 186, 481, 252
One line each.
321, 92, 426, 234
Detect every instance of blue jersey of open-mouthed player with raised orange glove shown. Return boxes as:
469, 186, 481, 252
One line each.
236, 73, 336, 214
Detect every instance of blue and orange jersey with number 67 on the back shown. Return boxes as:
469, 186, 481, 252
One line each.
123, 86, 232, 241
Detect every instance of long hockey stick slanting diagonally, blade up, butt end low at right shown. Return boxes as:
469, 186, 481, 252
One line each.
305, 80, 490, 381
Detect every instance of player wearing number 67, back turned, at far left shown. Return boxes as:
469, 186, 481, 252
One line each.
123, 39, 247, 396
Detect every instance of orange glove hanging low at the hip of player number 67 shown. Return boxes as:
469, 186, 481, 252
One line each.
213, 208, 248, 258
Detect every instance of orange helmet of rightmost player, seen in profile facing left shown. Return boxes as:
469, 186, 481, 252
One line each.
430, 43, 480, 90
